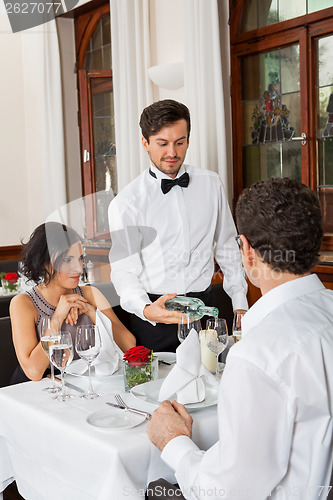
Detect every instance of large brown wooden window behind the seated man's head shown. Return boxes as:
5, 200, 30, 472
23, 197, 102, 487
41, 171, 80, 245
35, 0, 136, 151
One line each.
230, 0, 333, 262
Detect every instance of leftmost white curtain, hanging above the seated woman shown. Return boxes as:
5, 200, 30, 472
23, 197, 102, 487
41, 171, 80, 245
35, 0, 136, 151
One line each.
21, 20, 66, 225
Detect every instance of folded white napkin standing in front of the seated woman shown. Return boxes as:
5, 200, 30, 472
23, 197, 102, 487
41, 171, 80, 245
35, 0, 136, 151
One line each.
66, 309, 123, 376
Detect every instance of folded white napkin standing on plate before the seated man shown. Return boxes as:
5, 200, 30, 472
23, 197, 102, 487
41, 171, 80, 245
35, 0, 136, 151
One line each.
158, 328, 218, 404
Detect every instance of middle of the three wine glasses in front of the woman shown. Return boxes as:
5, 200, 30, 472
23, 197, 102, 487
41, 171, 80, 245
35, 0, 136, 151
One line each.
50, 332, 74, 401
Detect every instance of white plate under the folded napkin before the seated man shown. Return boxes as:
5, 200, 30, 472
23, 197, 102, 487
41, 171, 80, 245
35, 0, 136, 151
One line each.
131, 378, 219, 410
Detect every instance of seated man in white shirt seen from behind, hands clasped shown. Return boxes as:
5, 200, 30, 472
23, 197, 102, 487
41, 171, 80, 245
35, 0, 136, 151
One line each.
148, 178, 333, 500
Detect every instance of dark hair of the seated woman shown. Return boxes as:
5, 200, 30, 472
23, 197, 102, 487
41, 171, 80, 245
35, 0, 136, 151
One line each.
22, 222, 81, 285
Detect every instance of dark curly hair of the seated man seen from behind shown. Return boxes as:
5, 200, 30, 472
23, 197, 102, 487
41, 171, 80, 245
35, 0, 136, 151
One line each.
236, 177, 323, 275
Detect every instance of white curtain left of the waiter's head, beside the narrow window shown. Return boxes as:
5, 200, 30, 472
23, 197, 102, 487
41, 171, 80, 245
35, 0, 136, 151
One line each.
110, 0, 153, 189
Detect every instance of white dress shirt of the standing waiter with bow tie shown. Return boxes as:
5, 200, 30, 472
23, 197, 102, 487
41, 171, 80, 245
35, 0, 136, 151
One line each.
109, 165, 247, 319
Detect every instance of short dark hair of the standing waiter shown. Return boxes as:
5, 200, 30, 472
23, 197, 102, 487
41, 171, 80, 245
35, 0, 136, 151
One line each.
140, 99, 191, 144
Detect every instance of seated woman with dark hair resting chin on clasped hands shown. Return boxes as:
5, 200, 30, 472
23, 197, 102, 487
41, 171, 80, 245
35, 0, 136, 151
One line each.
10, 222, 136, 384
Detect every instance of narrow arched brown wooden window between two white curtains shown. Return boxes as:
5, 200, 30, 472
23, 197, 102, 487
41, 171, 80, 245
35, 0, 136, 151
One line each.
75, 4, 118, 240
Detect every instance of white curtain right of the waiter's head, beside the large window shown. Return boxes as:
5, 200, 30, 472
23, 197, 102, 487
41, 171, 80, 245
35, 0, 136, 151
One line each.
184, 0, 229, 199
